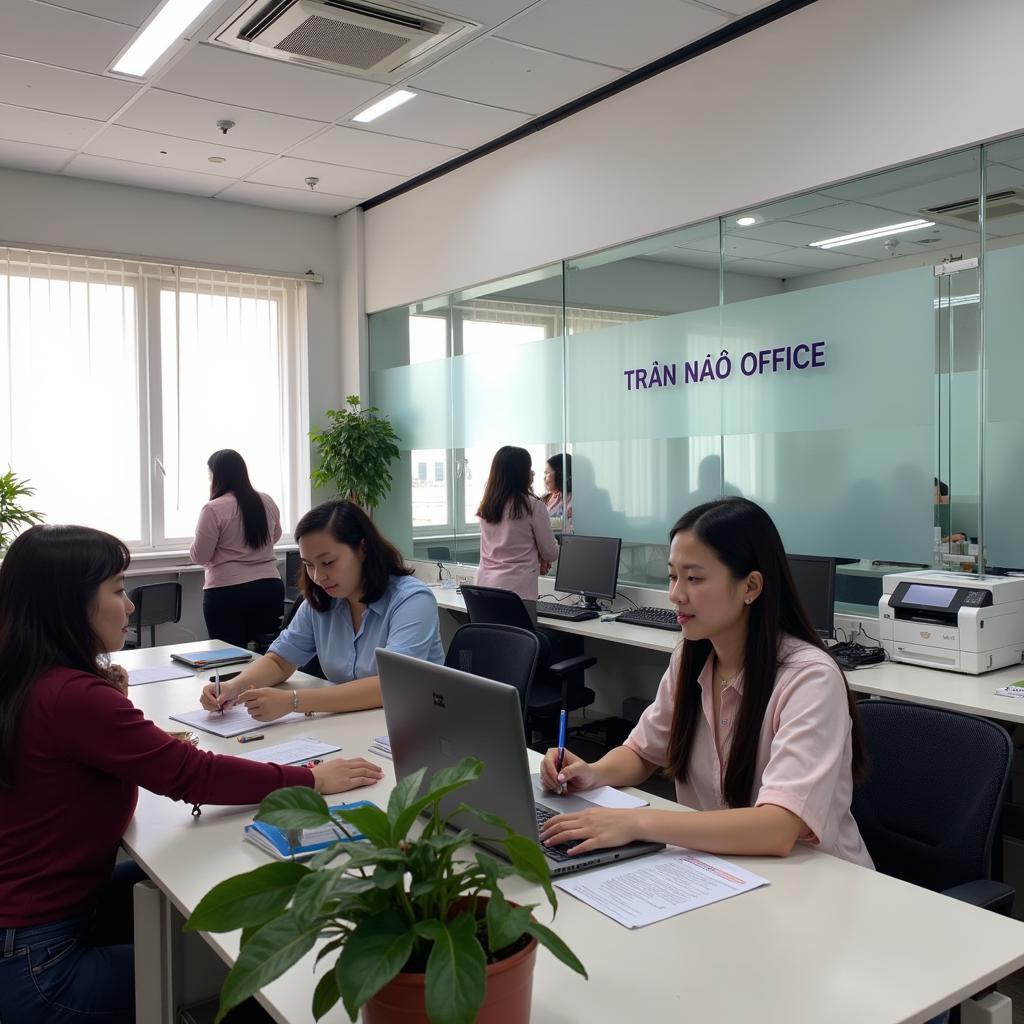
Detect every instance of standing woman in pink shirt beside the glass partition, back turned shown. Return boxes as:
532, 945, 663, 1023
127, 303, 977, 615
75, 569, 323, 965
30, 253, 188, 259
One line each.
476, 444, 558, 601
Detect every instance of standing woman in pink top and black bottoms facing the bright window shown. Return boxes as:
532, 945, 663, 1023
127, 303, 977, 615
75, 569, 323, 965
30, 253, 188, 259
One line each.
188, 449, 285, 647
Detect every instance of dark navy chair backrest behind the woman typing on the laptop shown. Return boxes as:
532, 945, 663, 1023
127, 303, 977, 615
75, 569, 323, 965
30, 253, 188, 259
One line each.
853, 700, 1013, 892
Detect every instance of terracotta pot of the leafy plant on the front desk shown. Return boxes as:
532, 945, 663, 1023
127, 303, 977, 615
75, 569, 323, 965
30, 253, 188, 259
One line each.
362, 937, 537, 1024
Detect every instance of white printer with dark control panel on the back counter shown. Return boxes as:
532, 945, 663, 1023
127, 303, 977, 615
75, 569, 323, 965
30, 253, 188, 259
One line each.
879, 569, 1024, 675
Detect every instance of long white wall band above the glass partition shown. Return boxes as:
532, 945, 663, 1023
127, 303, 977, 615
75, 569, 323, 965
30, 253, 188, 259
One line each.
366, 0, 1024, 311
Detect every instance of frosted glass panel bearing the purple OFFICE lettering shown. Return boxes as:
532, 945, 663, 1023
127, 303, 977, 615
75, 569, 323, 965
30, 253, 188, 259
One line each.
566, 260, 935, 562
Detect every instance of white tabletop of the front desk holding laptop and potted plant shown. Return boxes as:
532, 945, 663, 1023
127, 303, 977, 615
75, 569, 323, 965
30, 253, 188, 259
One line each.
117, 638, 1024, 1024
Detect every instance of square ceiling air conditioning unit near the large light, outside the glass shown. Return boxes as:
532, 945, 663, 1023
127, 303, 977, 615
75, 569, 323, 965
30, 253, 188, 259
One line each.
213, 0, 478, 82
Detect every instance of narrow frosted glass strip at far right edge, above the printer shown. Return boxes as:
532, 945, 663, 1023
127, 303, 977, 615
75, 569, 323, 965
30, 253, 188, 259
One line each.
984, 247, 1024, 568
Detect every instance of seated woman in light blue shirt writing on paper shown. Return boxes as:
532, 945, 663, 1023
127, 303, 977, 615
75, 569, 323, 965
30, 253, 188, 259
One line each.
202, 499, 444, 722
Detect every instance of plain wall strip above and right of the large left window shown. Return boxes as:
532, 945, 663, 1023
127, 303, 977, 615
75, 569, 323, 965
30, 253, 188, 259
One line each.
0, 169, 343, 450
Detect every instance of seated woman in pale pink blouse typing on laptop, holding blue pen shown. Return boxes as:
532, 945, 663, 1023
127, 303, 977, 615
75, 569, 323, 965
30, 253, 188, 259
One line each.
541, 498, 873, 867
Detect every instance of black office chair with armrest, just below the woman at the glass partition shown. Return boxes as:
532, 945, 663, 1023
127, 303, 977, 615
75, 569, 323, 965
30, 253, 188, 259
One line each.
462, 584, 597, 740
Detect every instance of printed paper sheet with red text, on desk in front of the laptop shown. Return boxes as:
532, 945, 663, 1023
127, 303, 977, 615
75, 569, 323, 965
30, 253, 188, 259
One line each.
555, 850, 768, 928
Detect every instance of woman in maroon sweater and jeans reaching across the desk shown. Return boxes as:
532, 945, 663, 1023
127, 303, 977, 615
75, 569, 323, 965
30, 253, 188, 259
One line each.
0, 526, 382, 1024
